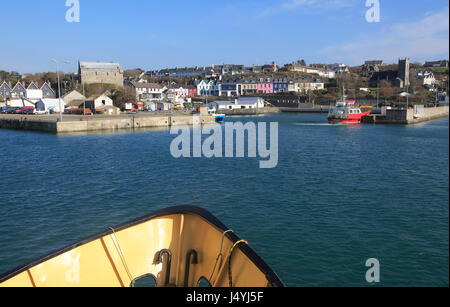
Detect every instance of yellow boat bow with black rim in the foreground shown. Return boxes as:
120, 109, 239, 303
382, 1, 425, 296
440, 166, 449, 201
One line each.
0, 206, 284, 287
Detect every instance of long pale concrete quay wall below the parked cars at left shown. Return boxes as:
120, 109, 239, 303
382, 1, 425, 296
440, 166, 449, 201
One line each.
0, 112, 215, 133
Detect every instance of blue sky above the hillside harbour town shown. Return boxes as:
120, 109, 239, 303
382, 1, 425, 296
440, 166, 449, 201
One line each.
0, 0, 449, 73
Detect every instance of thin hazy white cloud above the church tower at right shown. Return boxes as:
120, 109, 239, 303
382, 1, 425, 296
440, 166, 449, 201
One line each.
323, 8, 449, 65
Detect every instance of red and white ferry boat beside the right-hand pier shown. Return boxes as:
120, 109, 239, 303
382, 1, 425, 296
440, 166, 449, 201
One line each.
328, 99, 372, 124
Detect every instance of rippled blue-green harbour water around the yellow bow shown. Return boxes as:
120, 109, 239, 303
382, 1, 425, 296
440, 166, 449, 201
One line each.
0, 115, 449, 286
